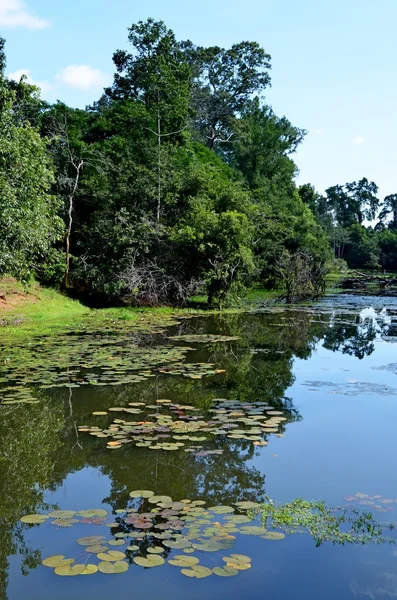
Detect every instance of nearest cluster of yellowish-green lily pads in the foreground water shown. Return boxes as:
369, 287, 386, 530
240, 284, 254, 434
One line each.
21, 490, 285, 579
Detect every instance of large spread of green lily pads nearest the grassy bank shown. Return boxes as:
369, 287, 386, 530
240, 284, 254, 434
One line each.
0, 328, 239, 405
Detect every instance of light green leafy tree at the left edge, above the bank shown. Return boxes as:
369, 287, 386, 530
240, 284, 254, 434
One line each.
0, 79, 61, 279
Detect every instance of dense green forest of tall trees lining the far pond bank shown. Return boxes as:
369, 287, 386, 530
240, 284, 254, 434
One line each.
0, 19, 397, 305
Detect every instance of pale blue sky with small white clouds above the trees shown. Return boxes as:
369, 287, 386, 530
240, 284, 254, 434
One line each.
0, 0, 397, 198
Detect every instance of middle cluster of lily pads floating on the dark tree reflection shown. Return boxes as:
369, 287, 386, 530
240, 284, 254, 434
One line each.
79, 398, 287, 456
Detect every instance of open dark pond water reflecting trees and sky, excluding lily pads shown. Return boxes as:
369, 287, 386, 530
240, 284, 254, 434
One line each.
0, 296, 397, 600
